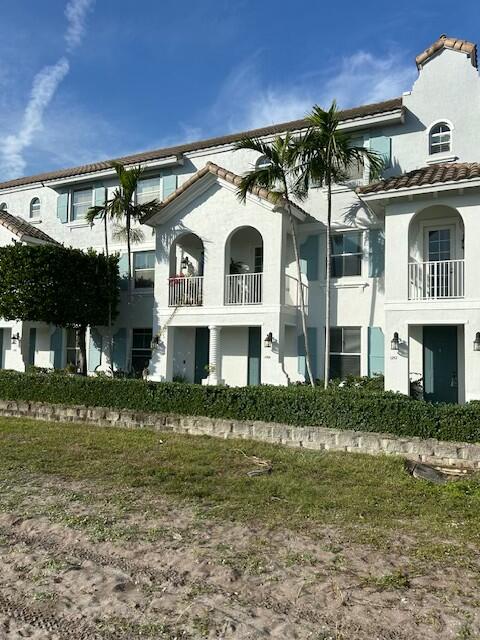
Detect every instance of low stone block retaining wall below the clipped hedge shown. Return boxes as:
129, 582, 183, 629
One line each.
0, 400, 480, 469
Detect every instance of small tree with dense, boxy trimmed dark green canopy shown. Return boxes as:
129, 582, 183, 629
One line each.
0, 243, 119, 375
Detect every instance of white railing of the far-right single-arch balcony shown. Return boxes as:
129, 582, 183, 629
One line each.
408, 260, 465, 300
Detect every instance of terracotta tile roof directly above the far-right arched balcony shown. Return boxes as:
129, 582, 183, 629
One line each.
357, 162, 480, 194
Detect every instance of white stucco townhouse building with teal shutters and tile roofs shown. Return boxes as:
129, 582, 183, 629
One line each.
0, 36, 480, 402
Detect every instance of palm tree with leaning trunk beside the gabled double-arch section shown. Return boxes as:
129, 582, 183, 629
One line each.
235, 133, 315, 387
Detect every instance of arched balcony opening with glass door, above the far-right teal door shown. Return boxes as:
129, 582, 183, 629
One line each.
408, 205, 465, 300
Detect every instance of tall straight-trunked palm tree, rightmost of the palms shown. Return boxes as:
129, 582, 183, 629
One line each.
298, 100, 384, 388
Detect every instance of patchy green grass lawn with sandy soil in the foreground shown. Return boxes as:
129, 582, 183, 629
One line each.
0, 419, 480, 639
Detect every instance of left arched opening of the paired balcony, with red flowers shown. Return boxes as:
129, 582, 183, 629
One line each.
168, 233, 205, 307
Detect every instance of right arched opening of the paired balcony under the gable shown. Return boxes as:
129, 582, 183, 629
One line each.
225, 227, 263, 305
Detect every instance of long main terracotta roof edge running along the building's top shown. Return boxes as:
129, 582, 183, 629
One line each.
0, 98, 402, 189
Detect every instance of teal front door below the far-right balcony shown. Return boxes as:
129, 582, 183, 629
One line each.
423, 326, 458, 403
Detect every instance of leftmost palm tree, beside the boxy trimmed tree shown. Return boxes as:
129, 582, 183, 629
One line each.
87, 162, 161, 371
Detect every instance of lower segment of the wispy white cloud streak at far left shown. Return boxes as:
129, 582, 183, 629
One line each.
1, 58, 69, 178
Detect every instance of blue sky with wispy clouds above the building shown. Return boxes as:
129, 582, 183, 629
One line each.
0, 0, 480, 180
